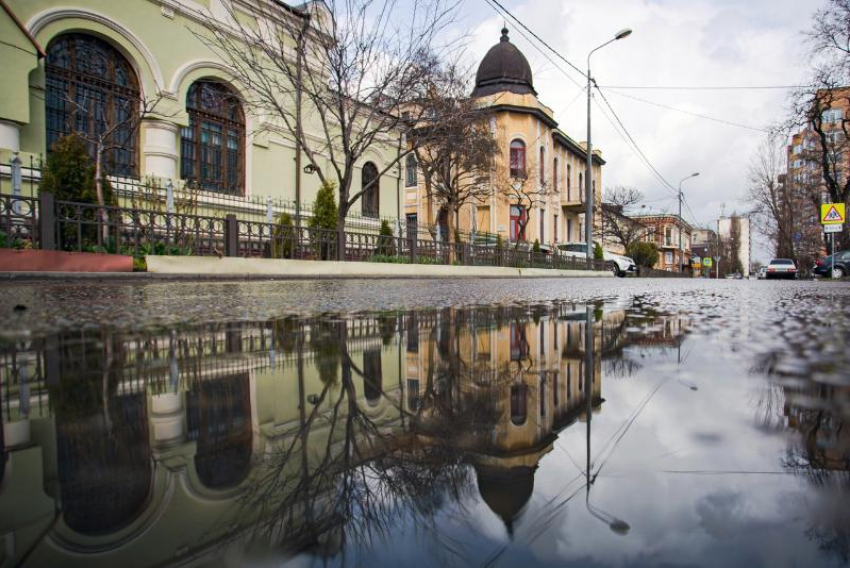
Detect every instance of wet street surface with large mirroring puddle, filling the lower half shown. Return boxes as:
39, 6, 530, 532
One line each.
0, 279, 850, 567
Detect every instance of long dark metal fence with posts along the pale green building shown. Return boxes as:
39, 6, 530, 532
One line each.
0, 192, 613, 270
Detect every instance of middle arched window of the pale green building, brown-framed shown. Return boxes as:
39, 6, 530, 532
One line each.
180, 81, 245, 195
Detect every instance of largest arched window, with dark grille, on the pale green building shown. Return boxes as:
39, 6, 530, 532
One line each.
44, 34, 141, 177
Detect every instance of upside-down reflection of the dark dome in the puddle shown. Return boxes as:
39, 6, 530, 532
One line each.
475, 466, 535, 536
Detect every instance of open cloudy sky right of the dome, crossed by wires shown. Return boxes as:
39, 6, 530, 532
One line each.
434, 0, 825, 261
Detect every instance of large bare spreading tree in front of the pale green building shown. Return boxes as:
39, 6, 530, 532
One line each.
198, 0, 454, 255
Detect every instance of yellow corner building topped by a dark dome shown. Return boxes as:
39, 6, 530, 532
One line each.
404, 28, 605, 248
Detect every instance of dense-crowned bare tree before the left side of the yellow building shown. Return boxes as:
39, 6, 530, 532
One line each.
410, 64, 499, 255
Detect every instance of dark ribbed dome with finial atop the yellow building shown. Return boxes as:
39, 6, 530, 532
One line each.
472, 28, 537, 97
